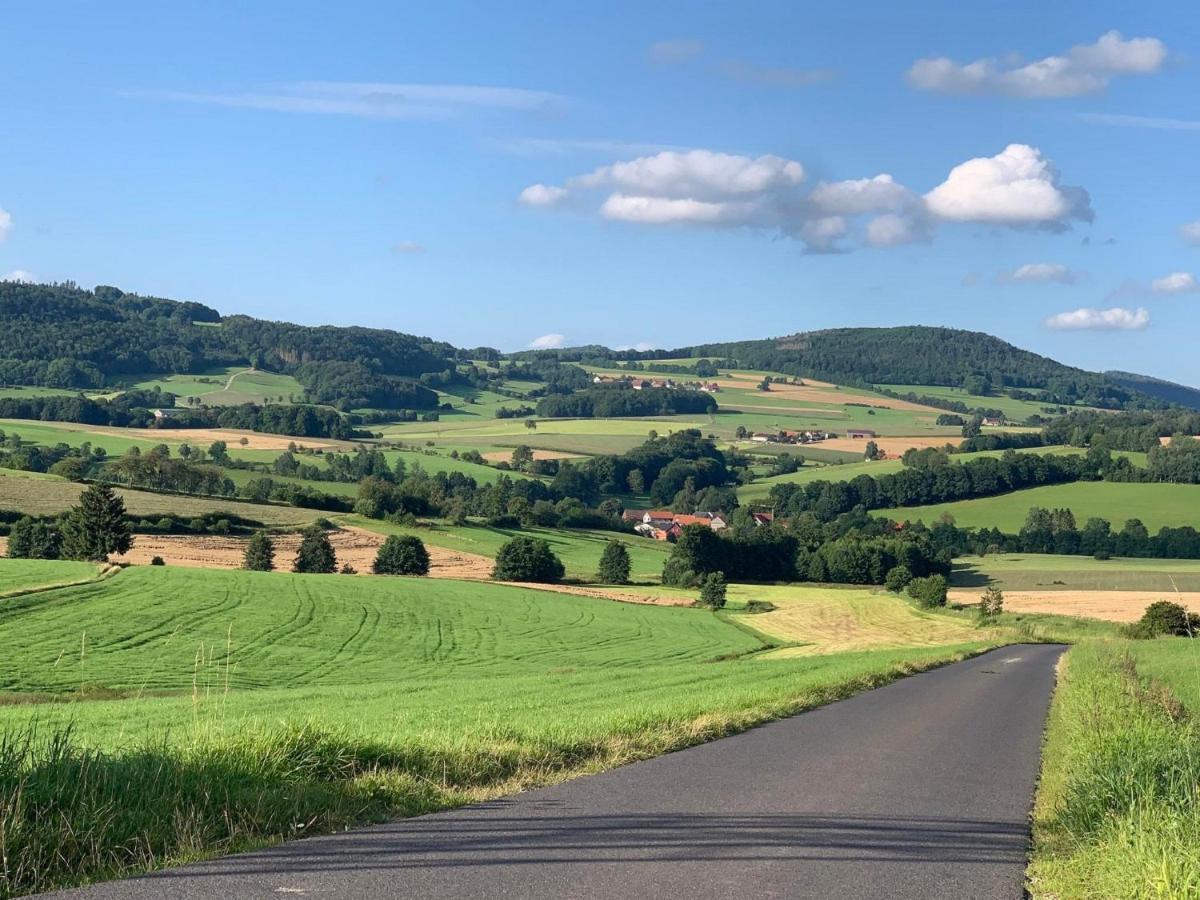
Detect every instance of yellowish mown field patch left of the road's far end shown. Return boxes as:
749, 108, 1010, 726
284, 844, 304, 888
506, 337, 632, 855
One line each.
730, 584, 988, 659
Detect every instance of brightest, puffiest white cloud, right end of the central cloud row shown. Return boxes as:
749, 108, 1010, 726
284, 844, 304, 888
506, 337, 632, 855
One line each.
925, 144, 1092, 230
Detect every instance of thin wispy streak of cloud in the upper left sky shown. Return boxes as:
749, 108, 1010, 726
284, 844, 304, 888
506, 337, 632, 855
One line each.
126, 82, 565, 119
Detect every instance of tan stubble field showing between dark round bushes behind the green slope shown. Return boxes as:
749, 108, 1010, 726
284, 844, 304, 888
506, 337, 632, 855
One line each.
114, 527, 492, 580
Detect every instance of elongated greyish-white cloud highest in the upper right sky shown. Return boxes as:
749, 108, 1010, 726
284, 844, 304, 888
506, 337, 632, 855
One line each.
906, 31, 1166, 98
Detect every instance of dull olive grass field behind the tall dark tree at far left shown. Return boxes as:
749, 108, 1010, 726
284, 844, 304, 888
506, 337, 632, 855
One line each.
0, 469, 328, 526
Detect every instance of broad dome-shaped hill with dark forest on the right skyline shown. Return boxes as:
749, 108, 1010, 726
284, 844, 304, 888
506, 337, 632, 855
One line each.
670, 325, 1147, 408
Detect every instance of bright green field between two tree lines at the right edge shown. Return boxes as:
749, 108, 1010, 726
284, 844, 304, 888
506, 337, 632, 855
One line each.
872, 481, 1200, 532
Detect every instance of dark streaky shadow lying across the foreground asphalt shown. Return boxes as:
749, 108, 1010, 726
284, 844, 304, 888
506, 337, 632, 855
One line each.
149, 800, 1028, 880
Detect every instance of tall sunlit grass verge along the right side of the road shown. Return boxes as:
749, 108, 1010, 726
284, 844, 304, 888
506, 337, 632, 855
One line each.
1030, 638, 1200, 899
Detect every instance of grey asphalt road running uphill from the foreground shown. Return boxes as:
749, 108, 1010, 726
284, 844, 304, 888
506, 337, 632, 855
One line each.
44, 646, 1062, 900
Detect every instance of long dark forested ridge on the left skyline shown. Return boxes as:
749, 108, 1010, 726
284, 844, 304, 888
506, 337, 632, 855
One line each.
0, 282, 455, 408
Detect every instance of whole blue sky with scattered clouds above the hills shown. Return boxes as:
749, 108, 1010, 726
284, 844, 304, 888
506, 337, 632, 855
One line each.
0, 2, 1200, 384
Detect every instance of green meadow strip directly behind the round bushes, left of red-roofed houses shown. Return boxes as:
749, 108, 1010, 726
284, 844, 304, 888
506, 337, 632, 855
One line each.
340, 516, 671, 581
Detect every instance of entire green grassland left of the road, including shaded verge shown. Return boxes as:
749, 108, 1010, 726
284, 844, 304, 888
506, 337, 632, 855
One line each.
0, 568, 983, 893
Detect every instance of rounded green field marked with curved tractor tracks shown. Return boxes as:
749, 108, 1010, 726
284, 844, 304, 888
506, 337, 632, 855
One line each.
0, 566, 758, 691
